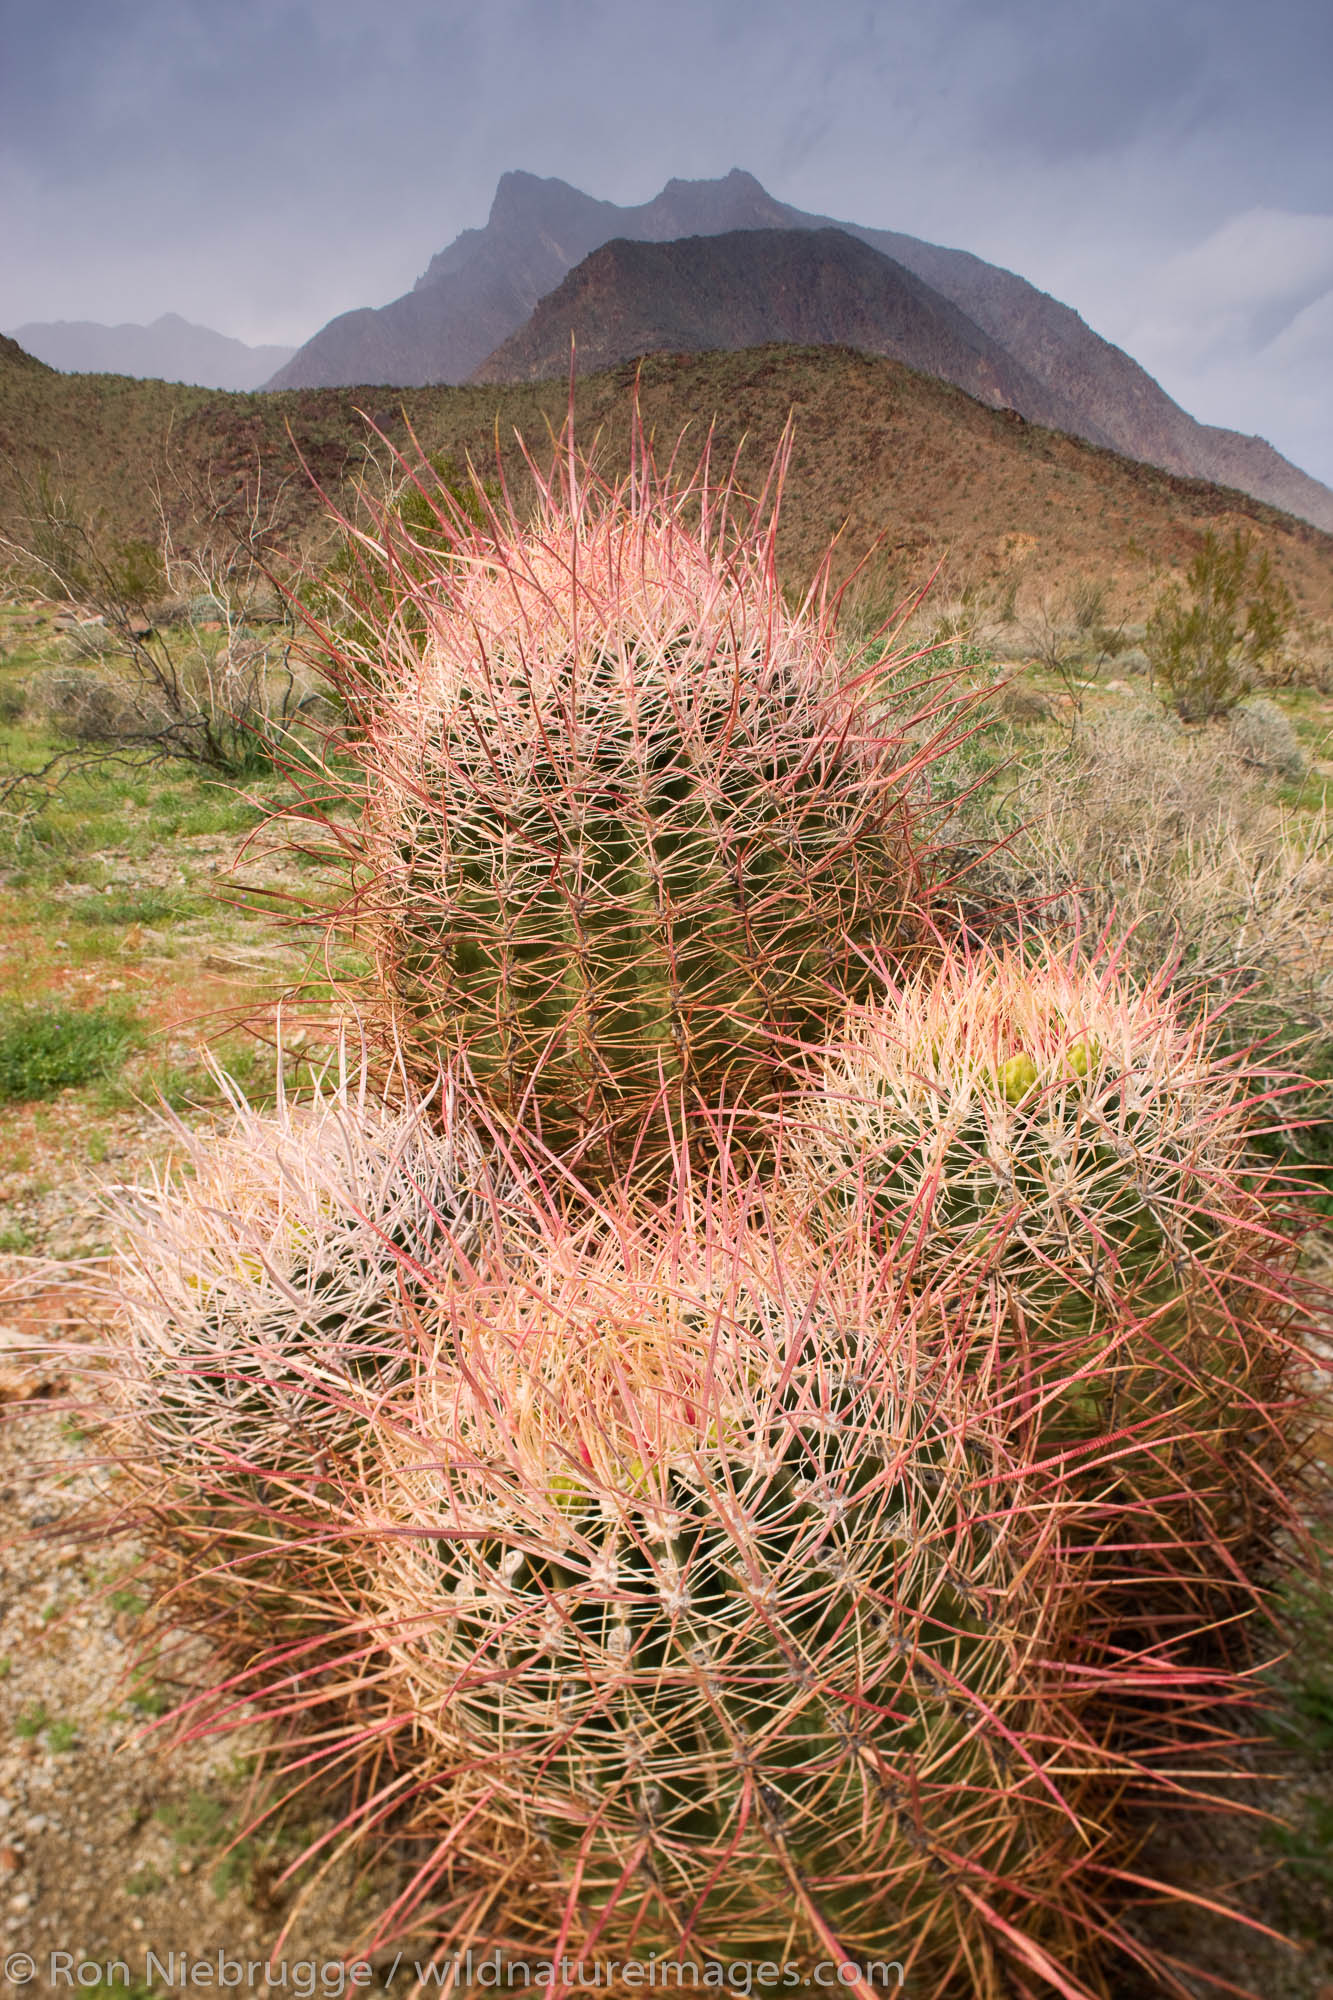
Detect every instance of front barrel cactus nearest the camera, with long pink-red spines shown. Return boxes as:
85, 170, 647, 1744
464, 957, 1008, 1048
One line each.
358, 1204, 1232, 1996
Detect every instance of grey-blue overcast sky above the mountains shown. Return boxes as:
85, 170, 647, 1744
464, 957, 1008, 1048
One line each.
0, 0, 1333, 482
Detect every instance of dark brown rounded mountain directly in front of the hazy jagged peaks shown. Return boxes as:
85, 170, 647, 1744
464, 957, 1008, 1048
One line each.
472, 230, 1107, 442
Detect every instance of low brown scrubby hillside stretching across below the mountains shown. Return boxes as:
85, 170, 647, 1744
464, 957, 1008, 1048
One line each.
0, 344, 1333, 620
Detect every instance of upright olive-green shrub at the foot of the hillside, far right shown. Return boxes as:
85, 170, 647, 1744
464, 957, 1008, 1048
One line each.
1143, 528, 1293, 722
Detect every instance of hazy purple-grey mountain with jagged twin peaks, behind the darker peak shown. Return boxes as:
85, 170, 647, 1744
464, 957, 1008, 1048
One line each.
268, 168, 1333, 530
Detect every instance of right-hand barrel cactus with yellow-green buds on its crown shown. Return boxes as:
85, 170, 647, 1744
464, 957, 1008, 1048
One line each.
789, 946, 1301, 1574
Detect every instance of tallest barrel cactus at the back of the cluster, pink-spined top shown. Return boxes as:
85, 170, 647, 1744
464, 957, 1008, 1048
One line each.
326, 424, 955, 1172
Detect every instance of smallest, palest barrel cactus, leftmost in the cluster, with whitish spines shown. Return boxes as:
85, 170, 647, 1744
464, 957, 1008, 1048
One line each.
112, 1064, 492, 1480
